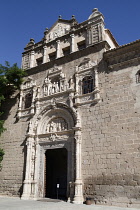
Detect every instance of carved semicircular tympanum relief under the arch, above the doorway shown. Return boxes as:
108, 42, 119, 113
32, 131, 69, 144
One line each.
46, 117, 68, 133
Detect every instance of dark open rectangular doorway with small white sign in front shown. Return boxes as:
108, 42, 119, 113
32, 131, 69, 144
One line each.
45, 148, 67, 200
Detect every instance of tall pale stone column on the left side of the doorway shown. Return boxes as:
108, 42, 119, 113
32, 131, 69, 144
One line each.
22, 136, 34, 200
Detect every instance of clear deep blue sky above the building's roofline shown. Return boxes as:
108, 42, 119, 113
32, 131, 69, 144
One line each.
0, 0, 140, 66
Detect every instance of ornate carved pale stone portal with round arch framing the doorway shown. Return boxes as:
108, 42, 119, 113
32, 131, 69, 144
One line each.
22, 104, 83, 203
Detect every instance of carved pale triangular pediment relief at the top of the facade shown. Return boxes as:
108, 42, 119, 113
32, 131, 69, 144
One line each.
47, 20, 71, 41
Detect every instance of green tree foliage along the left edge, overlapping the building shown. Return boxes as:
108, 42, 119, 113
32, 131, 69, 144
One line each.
0, 61, 26, 168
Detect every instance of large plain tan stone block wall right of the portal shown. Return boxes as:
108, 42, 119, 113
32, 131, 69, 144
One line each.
81, 62, 140, 207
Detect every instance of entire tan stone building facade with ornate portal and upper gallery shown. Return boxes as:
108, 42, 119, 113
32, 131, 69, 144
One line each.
0, 9, 140, 207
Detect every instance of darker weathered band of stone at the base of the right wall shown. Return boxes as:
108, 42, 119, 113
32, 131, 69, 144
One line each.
84, 174, 140, 203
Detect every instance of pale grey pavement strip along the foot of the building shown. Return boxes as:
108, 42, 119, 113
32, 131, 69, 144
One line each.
0, 197, 138, 210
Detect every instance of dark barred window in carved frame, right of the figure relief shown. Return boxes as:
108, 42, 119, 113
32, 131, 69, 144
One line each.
82, 76, 94, 94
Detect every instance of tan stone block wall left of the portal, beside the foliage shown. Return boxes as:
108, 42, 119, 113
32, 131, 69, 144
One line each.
0, 93, 28, 195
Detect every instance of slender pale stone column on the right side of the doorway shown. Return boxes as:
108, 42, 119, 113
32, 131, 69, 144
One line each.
73, 129, 84, 204
